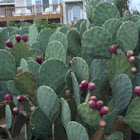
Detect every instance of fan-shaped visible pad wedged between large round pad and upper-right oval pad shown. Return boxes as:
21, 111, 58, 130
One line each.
102, 18, 122, 44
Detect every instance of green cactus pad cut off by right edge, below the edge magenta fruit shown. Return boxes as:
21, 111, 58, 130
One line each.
125, 97, 140, 133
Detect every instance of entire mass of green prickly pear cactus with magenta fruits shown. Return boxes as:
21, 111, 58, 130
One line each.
0, 2, 140, 140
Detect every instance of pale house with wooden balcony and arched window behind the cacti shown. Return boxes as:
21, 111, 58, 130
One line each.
0, 0, 86, 24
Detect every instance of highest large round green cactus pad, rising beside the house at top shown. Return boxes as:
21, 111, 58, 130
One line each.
92, 2, 120, 26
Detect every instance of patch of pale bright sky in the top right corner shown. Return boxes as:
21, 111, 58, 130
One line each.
129, 0, 140, 13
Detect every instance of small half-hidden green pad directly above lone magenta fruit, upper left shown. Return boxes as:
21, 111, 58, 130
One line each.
28, 49, 44, 59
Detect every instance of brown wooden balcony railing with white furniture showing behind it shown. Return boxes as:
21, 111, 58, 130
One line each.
0, 4, 62, 17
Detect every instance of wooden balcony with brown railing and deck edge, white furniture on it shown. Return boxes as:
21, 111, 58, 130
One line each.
0, 4, 63, 22
